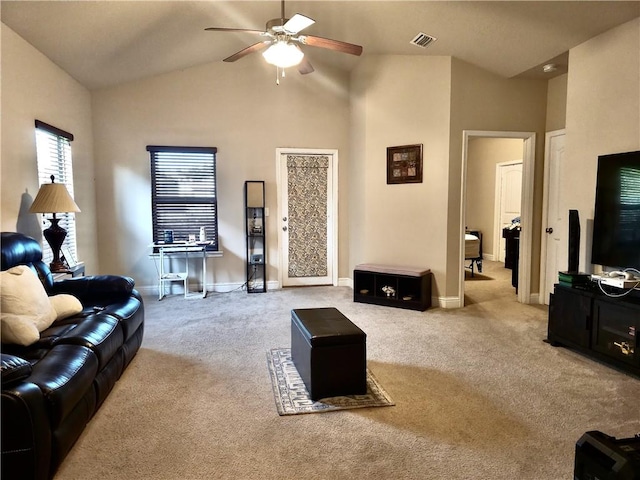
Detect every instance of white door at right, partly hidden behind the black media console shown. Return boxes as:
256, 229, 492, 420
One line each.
540, 130, 566, 305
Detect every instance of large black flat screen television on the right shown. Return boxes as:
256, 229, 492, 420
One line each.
591, 151, 640, 269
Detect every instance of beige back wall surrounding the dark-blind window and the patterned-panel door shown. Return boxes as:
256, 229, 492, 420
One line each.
93, 55, 350, 289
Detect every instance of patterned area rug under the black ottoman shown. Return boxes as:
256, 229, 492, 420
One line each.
267, 348, 395, 415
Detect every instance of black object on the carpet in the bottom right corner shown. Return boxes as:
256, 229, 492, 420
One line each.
573, 431, 640, 480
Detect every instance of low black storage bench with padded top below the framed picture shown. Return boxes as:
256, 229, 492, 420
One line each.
353, 263, 431, 311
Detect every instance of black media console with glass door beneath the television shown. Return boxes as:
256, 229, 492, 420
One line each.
548, 282, 640, 376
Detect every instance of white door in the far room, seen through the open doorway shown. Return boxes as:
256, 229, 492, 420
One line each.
493, 160, 522, 262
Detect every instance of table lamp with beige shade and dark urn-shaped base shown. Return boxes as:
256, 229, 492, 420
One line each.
29, 175, 80, 272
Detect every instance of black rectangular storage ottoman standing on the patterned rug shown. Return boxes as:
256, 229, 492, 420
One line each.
291, 308, 367, 400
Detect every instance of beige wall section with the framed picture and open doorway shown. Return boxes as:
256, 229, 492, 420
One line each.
349, 56, 547, 305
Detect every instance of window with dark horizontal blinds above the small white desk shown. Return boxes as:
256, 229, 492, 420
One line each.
147, 145, 218, 250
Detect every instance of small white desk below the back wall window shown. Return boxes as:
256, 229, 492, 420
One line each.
151, 242, 211, 300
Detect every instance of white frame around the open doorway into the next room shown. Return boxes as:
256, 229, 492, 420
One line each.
458, 130, 536, 306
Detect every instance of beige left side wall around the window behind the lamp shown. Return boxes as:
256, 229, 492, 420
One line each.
0, 24, 98, 272
